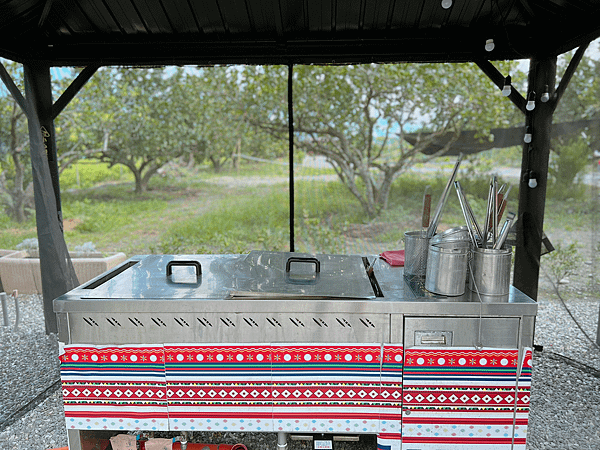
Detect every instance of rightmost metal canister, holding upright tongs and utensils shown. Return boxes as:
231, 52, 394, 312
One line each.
469, 247, 512, 302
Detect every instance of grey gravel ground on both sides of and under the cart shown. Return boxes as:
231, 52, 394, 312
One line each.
0, 292, 600, 450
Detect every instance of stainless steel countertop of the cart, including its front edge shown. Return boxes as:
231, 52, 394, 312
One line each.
54, 252, 537, 316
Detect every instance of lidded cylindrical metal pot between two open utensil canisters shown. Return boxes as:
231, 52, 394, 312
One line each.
425, 241, 471, 296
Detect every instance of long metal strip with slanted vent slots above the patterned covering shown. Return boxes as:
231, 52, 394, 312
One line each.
67, 311, 390, 344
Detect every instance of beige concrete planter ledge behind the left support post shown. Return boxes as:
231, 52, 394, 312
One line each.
0, 250, 127, 294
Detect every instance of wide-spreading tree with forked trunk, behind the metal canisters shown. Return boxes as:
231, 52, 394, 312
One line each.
243, 64, 514, 217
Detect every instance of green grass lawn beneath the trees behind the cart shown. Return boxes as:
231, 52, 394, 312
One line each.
0, 162, 589, 256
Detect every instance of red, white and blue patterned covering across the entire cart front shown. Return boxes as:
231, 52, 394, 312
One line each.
60, 344, 532, 450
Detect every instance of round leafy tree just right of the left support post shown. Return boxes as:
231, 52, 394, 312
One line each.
61, 68, 199, 193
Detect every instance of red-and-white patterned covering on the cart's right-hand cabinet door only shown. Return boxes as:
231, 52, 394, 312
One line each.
402, 347, 531, 450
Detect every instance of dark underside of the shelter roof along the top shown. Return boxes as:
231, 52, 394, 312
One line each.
0, 0, 600, 66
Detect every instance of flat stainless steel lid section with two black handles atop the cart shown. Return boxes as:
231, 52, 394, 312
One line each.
84, 251, 375, 300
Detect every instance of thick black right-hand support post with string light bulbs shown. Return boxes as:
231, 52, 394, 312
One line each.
513, 57, 556, 300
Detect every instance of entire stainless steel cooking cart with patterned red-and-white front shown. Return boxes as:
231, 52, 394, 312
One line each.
54, 251, 537, 450
